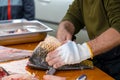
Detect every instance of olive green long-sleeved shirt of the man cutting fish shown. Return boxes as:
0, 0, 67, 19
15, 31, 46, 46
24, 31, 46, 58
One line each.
62, 0, 120, 39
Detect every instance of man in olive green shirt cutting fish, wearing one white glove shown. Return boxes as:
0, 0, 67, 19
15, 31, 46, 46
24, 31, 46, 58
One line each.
45, 0, 120, 80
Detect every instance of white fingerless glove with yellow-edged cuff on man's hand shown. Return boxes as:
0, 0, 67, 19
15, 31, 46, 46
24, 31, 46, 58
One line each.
56, 41, 93, 64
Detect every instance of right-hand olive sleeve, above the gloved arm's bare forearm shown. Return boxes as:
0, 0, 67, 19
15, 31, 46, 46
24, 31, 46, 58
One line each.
105, 0, 120, 32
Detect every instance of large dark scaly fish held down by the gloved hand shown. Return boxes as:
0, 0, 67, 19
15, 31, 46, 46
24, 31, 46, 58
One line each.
28, 36, 93, 70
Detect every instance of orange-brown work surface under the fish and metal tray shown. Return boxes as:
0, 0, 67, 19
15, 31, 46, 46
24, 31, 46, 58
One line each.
7, 42, 114, 80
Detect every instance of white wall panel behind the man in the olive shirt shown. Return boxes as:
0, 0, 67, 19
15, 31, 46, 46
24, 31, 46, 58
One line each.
35, 0, 73, 23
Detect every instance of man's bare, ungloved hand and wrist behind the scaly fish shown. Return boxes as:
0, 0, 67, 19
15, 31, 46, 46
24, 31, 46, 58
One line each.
56, 21, 74, 43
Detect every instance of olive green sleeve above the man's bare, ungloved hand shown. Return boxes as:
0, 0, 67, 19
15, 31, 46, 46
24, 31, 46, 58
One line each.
62, 0, 84, 34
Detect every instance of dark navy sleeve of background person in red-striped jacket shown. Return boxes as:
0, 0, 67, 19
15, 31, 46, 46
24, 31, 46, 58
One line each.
23, 0, 35, 20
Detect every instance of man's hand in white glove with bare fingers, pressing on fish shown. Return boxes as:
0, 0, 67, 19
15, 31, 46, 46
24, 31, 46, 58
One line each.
46, 41, 92, 68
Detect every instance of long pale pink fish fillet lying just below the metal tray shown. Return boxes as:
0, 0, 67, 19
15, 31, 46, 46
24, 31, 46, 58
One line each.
0, 46, 32, 63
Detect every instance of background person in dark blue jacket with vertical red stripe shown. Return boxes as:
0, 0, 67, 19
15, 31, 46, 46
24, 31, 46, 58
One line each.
0, 0, 35, 20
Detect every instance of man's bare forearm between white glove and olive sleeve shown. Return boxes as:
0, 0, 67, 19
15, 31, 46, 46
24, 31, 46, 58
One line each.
87, 28, 120, 56
